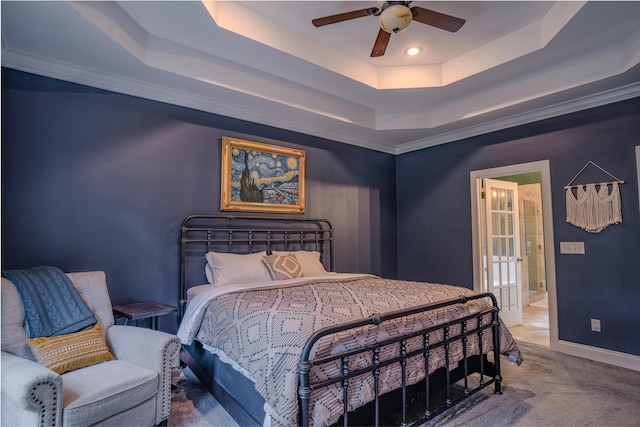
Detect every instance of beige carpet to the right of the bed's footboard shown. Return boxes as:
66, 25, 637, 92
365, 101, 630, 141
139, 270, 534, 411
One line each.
427, 342, 640, 427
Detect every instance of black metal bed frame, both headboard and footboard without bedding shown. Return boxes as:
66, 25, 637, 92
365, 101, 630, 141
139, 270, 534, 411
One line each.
179, 215, 502, 426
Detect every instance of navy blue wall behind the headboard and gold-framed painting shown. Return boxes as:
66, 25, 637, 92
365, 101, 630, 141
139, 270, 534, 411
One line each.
2, 68, 397, 330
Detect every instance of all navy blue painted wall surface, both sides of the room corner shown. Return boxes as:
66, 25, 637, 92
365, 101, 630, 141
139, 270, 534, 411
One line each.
2, 69, 640, 355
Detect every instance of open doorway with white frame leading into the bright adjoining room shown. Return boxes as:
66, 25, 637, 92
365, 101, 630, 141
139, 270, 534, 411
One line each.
470, 161, 558, 347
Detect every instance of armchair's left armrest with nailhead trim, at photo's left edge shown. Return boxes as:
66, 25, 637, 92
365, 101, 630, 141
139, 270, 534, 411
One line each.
1, 351, 63, 426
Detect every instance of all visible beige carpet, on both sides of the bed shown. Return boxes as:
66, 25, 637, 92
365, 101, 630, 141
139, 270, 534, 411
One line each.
169, 342, 640, 427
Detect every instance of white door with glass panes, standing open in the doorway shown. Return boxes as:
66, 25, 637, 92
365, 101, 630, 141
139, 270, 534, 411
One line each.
483, 178, 522, 326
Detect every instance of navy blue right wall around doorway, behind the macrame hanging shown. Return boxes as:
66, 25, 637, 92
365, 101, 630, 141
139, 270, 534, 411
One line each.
396, 98, 640, 355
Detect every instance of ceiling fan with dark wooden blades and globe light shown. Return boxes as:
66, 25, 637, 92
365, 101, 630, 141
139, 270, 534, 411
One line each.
311, 1, 466, 57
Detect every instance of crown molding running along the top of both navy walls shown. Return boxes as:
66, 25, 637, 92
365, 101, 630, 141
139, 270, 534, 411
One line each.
2, 50, 640, 155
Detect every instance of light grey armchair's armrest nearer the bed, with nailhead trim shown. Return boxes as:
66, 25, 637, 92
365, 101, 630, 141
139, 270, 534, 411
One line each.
106, 325, 181, 425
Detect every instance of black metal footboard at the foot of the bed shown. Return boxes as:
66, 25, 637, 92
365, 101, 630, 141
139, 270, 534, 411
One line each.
298, 293, 502, 426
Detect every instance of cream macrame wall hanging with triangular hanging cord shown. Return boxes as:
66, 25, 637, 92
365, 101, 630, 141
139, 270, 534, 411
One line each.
564, 160, 624, 233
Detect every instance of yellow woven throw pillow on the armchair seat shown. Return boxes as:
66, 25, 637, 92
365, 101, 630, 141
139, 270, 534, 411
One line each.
29, 323, 115, 374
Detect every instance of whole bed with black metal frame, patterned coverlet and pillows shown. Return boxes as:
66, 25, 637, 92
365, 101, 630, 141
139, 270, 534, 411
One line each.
178, 215, 522, 426
